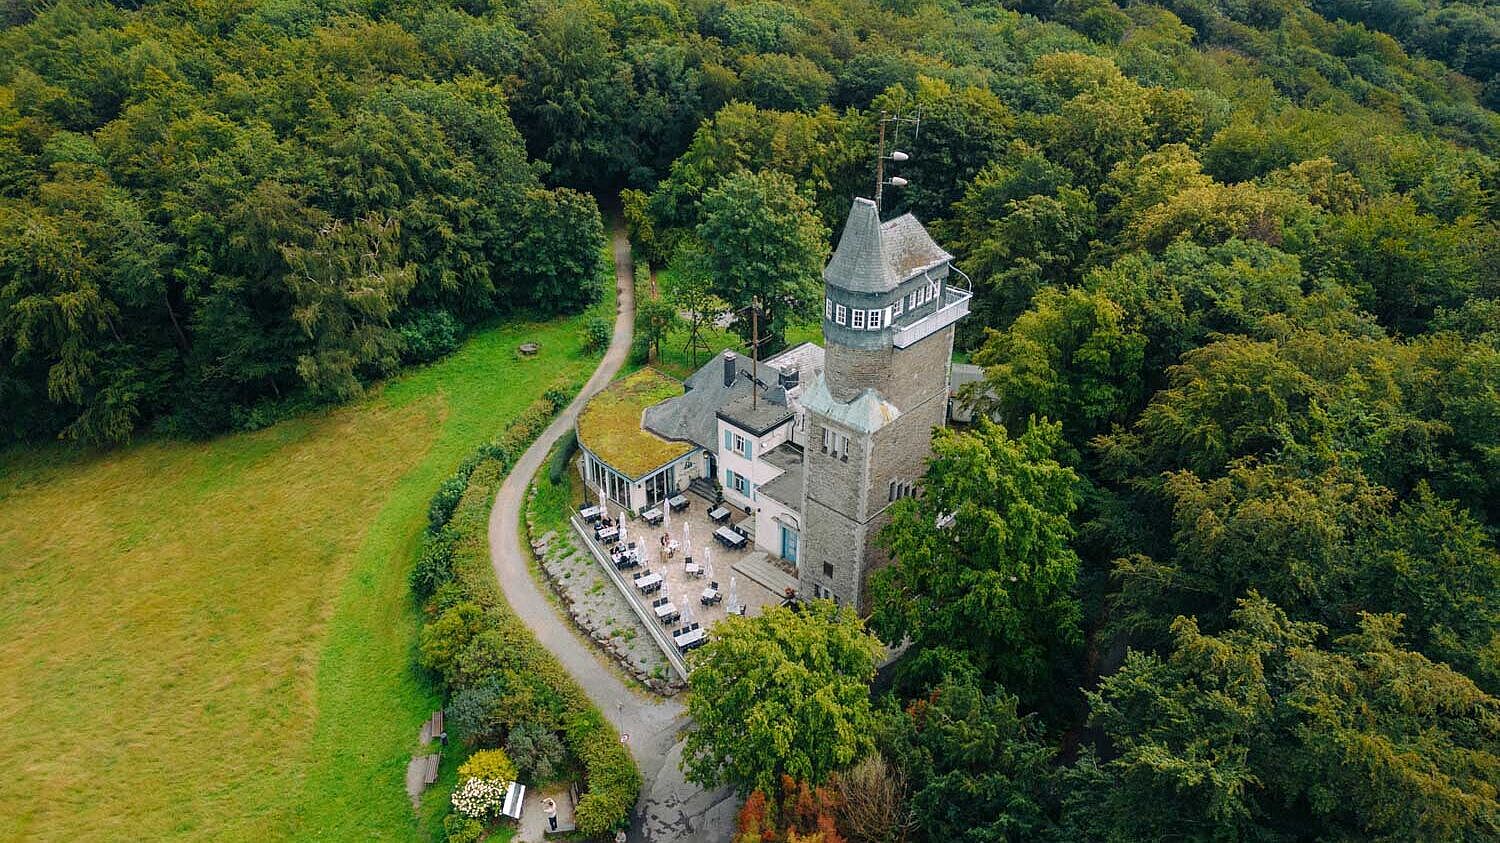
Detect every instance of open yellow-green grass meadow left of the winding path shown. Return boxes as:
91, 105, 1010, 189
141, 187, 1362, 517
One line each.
0, 303, 612, 840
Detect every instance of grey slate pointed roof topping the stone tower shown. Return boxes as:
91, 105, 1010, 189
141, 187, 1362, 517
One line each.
824, 197, 953, 293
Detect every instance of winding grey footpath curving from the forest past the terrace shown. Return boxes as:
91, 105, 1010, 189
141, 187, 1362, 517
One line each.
489, 219, 738, 843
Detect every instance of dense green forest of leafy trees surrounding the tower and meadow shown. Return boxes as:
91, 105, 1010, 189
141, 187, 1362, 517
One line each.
0, 0, 1500, 843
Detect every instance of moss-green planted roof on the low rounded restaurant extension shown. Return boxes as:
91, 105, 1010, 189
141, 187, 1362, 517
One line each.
578, 369, 695, 479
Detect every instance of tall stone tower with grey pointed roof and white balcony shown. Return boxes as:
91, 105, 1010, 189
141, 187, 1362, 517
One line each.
798, 198, 971, 603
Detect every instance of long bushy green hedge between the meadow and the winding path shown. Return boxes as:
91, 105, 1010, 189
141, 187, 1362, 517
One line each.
413, 382, 641, 836
